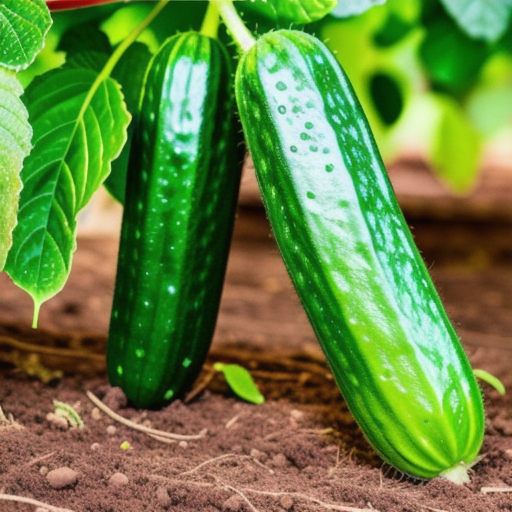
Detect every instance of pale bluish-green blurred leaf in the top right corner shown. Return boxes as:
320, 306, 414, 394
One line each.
441, 0, 512, 43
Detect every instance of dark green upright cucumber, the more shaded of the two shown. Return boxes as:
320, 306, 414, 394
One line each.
107, 32, 241, 408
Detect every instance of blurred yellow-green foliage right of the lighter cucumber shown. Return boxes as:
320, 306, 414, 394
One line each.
314, 0, 512, 194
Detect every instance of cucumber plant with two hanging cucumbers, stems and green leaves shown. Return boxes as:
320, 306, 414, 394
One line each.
0, 0, 506, 482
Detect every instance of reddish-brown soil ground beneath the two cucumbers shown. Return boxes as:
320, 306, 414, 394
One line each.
0, 161, 512, 512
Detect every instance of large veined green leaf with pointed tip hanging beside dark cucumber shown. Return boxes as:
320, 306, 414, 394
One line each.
6, 68, 130, 323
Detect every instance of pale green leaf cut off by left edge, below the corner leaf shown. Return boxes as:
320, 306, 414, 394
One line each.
0, 67, 32, 271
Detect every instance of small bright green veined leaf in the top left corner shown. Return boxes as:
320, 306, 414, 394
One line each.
0, 0, 52, 71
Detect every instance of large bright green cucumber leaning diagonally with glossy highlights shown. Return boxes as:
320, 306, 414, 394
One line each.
235, 30, 484, 478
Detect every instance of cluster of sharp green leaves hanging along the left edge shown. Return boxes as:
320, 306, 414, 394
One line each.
0, 0, 133, 325
